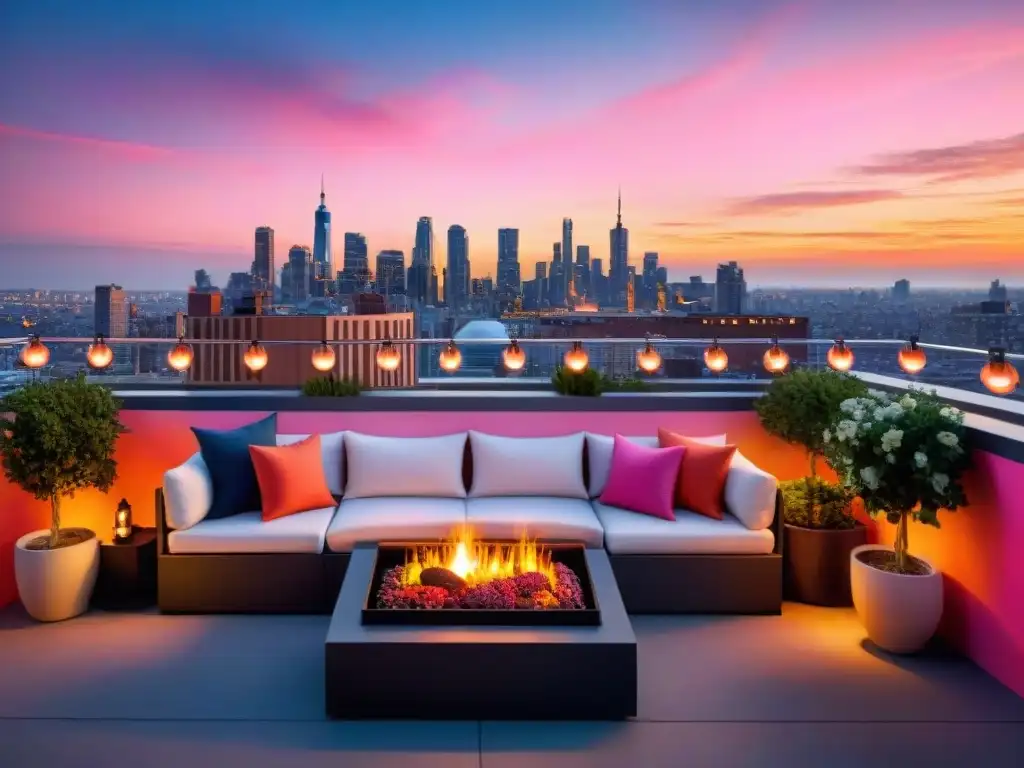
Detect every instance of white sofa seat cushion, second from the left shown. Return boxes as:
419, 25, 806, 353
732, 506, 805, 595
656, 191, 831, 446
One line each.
327, 497, 466, 552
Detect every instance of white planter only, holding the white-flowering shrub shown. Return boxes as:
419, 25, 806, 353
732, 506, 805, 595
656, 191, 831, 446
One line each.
850, 544, 942, 653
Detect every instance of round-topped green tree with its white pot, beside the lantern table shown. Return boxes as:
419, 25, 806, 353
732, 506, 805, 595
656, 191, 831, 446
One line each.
0, 375, 124, 622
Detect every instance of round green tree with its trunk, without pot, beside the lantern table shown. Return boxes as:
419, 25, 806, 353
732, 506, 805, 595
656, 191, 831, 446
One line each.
0, 374, 125, 549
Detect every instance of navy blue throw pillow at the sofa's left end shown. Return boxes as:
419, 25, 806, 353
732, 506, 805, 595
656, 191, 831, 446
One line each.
193, 414, 278, 520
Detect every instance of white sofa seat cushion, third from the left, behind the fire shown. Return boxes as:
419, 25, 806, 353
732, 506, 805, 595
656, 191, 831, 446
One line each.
466, 496, 604, 547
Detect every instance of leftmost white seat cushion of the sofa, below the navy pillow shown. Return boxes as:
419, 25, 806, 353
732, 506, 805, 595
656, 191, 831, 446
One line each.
167, 507, 334, 555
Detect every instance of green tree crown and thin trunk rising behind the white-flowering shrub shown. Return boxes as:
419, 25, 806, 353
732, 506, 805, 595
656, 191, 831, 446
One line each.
755, 369, 867, 477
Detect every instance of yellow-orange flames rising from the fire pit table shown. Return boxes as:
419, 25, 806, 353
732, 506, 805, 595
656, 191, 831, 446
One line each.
402, 528, 556, 585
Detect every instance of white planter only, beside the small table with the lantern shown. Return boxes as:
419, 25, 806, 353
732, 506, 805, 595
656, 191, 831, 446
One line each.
14, 529, 99, 622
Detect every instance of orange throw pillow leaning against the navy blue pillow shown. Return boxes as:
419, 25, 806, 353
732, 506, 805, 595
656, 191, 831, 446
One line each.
249, 434, 335, 522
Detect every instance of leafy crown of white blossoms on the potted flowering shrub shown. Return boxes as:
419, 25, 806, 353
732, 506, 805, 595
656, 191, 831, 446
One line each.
822, 390, 970, 527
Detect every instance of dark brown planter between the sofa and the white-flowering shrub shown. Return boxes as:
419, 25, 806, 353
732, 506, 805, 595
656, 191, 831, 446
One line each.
782, 522, 867, 606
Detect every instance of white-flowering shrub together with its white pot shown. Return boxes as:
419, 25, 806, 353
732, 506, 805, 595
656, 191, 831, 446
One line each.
823, 391, 970, 653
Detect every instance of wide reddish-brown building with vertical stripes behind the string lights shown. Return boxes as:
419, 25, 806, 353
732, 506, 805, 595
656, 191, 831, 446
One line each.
186, 312, 417, 389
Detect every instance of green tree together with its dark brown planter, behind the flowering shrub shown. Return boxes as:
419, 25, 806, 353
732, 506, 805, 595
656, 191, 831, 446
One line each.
756, 369, 867, 605
